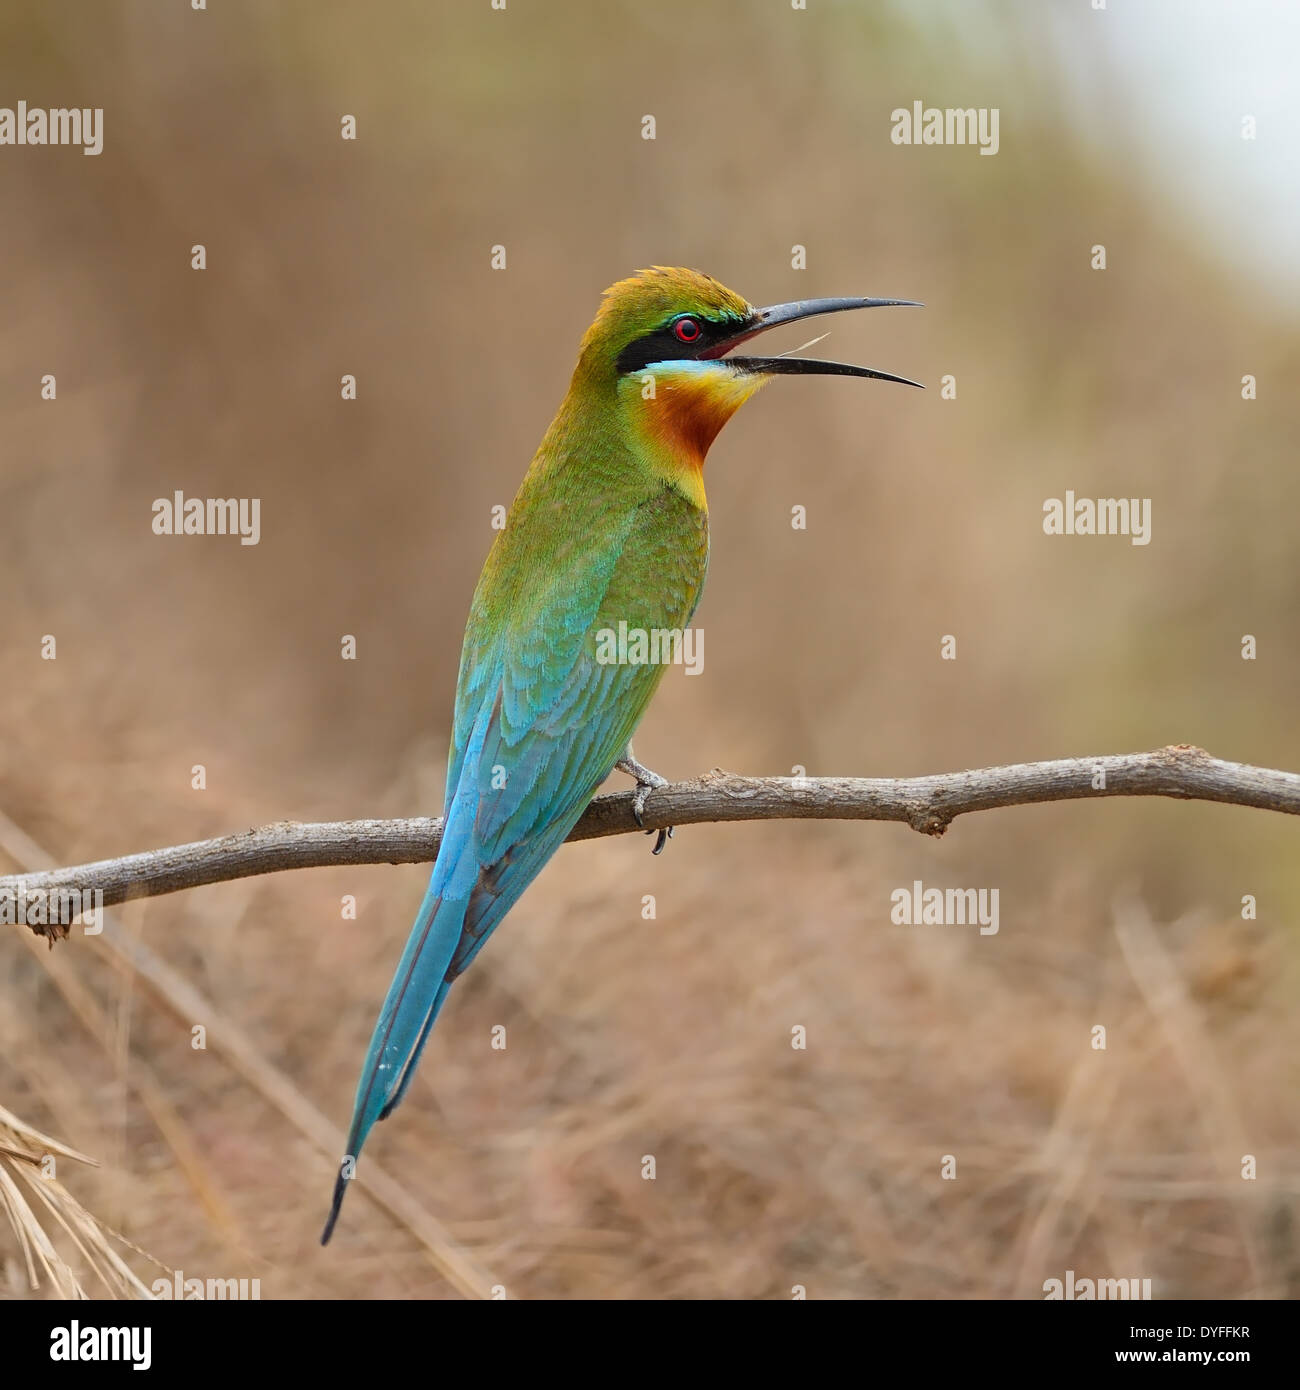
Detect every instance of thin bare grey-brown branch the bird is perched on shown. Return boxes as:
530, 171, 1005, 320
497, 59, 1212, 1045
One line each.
0, 744, 1300, 941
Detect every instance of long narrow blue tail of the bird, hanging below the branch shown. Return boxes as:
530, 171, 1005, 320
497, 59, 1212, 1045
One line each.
321, 867, 470, 1245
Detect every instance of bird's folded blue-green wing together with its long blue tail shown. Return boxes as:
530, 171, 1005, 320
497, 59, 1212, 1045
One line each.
321, 496, 706, 1244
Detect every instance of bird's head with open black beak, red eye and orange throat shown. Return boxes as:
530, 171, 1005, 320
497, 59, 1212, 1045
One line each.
574, 265, 920, 466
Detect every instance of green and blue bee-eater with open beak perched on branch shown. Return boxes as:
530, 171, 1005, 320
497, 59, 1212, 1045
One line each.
321, 265, 922, 1244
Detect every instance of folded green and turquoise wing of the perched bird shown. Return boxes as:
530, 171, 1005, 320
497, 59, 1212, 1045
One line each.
448, 489, 708, 977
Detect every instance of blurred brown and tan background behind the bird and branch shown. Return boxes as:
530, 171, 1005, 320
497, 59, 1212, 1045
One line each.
0, 0, 1300, 1298
